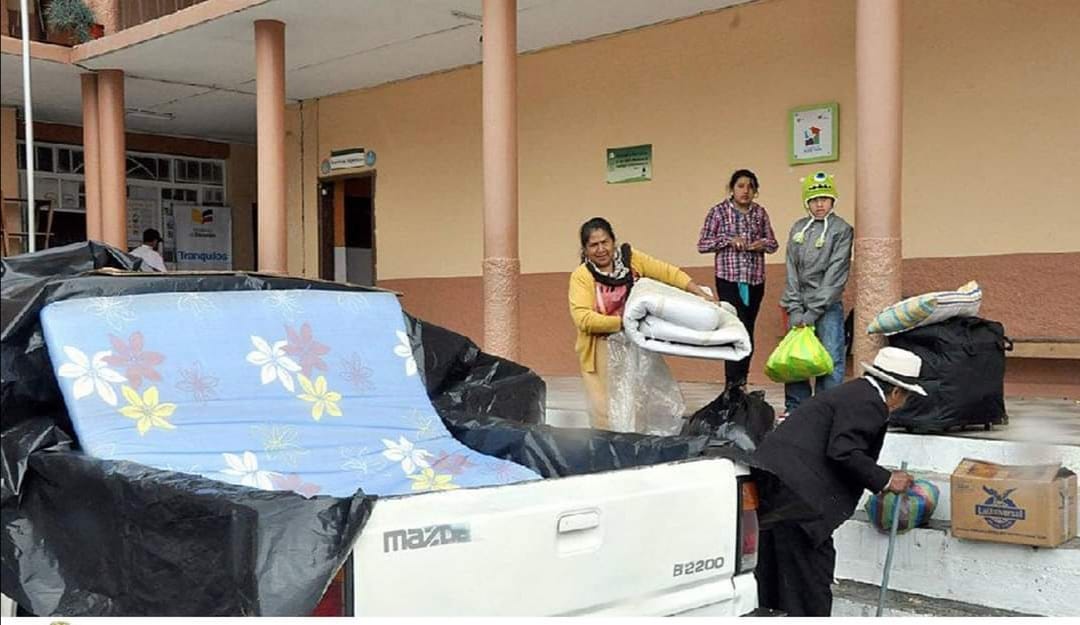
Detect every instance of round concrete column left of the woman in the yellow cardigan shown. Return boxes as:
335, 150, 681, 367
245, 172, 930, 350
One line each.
483, 0, 522, 359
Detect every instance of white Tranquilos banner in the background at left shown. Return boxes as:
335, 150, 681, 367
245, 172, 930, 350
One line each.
176, 206, 232, 271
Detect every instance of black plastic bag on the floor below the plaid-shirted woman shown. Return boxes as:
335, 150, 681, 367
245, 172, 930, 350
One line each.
683, 384, 777, 451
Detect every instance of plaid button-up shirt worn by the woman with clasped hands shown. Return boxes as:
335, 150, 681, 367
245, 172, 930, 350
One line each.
698, 198, 780, 284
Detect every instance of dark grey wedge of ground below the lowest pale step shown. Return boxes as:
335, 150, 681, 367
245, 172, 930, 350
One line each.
832, 580, 1030, 617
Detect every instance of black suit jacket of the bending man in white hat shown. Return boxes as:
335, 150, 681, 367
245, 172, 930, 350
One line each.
753, 378, 890, 544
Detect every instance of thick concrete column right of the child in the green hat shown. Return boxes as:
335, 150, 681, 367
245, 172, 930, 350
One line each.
853, 0, 902, 367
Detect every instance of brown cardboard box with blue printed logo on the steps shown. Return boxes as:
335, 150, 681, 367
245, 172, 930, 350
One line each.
950, 458, 1077, 547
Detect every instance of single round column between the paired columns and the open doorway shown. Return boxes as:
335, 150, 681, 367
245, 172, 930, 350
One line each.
255, 19, 287, 273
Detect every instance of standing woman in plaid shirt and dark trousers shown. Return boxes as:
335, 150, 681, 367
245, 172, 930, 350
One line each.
698, 169, 779, 384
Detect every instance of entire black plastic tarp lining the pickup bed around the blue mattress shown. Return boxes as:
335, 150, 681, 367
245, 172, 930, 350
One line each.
0, 243, 745, 616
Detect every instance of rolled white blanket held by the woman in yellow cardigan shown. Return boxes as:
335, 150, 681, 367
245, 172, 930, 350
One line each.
622, 277, 751, 361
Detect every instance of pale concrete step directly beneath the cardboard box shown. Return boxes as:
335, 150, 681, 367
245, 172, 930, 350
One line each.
834, 511, 1080, 616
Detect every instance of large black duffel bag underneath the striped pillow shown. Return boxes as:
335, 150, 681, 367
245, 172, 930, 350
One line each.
889, 317, 1012, 433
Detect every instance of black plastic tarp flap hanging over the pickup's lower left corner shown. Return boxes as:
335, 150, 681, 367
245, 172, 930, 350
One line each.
0, 419, 373, 615
